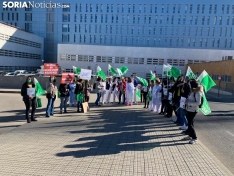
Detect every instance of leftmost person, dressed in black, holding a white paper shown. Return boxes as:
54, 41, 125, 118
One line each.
21, 76, 37, 123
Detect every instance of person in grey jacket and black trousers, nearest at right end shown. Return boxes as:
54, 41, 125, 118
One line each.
185, 79, 203, 144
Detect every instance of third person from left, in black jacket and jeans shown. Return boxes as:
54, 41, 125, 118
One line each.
59, 83, 70, 114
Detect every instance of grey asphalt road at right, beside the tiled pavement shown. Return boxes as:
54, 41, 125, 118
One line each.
195, 96, 234, 174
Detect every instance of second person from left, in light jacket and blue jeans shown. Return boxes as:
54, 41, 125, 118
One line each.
46, 76, 58, 117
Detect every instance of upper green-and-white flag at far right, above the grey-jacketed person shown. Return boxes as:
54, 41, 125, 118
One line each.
197, 70, 216, 92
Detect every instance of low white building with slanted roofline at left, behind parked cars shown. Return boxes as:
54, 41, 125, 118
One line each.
0, 23, 44, 71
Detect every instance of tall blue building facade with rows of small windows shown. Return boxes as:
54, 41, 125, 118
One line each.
0, 0, 234, 62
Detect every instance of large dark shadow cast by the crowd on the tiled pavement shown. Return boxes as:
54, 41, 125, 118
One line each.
57, 109, 188, 158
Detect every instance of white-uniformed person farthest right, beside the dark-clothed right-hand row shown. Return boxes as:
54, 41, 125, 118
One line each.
151, 78, 162, 113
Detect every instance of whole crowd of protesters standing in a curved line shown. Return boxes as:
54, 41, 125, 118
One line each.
21, 75, 203, 144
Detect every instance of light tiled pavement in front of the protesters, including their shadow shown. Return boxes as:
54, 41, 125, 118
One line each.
0, 94, 231, 176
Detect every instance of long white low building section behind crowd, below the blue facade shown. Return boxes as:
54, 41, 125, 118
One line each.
57, 44, 234, 78
